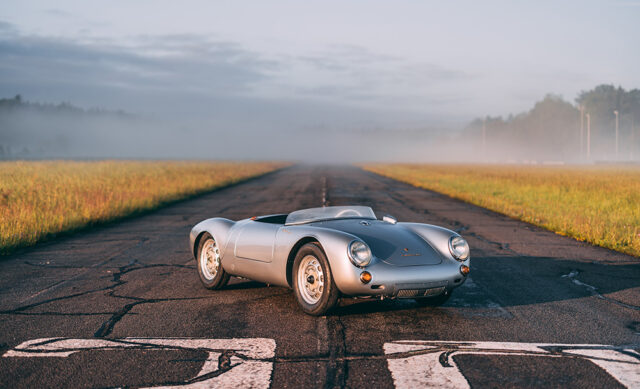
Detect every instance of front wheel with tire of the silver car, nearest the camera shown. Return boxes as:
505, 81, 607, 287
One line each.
292, 243, 340, 316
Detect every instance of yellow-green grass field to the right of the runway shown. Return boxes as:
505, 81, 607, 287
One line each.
363, 164, 640, 256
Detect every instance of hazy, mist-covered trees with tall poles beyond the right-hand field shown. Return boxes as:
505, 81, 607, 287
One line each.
464, 85, 640, 162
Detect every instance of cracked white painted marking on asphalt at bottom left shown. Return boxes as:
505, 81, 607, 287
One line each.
3, 338, 276, 388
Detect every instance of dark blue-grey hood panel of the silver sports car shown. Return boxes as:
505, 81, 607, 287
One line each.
312, 219, 442, 266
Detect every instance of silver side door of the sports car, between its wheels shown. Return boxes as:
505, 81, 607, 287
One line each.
234, 221, 280, 262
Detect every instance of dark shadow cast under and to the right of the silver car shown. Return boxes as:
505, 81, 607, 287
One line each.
216, 256, 640, 316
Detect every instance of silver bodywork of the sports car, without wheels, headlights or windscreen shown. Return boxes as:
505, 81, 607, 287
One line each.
190, 206, 470, 297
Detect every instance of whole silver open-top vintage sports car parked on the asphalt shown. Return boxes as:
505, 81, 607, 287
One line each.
190, 206, 470, 315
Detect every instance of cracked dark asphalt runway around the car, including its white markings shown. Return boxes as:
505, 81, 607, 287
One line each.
0, 166, 640, 388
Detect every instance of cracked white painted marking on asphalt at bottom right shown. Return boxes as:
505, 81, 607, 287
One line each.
384, 340, 640, 388
